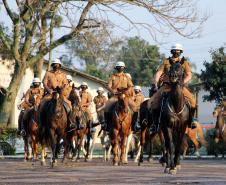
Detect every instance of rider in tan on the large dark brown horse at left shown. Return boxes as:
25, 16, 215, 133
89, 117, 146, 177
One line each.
40, 59, 74, 126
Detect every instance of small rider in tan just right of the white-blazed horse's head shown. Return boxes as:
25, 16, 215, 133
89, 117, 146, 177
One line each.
80, 82, 93, 128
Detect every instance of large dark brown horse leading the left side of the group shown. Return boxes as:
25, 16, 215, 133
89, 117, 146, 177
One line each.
38, 87, 68, 167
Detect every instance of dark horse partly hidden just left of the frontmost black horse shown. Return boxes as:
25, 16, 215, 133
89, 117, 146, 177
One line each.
136, 99, 166, 166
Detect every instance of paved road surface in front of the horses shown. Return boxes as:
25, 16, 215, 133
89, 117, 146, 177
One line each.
0, 159, 226, 185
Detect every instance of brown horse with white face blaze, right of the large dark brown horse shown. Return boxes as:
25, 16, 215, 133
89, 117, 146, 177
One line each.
63, 87, 91, 161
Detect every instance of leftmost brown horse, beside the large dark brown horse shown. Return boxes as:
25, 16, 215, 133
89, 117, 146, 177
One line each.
20, 94, 42, 161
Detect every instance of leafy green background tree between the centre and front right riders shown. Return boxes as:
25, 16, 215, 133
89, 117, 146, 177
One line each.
119, 37, 163, 86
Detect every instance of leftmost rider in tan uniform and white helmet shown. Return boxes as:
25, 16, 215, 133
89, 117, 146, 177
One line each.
18, 78, 44, 136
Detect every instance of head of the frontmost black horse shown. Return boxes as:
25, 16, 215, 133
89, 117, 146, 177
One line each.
169, 63, 183, 84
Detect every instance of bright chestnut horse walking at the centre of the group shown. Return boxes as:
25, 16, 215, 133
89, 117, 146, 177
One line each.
110, 88, 132, 165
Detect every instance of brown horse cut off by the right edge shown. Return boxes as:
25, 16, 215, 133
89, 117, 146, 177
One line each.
213, 105, 226, 143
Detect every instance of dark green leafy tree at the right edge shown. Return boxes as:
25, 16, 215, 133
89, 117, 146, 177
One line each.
200, 47, 226, 103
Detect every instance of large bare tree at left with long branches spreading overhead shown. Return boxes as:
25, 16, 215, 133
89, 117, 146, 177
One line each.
0, 0, 206, 123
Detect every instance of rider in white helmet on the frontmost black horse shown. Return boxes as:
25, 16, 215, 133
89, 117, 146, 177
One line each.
150, 44, 197, 131
